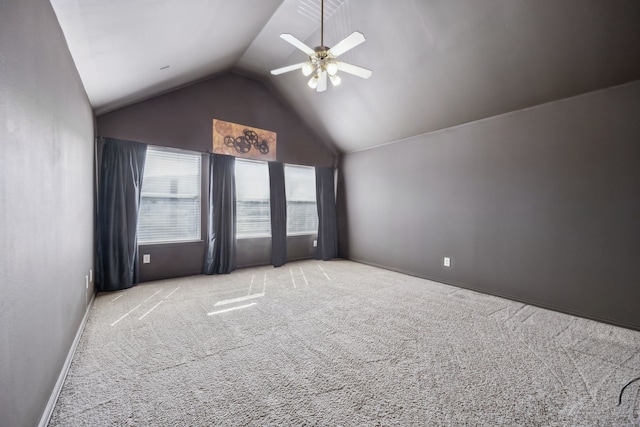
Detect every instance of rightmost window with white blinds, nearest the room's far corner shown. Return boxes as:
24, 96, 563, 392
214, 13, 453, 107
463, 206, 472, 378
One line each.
284, 165, 318, 235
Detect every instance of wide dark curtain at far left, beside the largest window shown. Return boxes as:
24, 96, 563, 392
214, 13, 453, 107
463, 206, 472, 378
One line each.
96, 138, 147, 291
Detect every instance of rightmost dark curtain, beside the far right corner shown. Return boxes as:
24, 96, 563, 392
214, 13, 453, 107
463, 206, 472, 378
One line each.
316, 167, 338, 261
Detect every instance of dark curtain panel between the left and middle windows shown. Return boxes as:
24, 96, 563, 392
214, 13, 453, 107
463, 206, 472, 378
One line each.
204, 154, 236, 274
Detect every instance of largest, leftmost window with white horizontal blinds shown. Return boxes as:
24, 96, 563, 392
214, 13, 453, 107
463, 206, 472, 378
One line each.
138, 147, 201, 244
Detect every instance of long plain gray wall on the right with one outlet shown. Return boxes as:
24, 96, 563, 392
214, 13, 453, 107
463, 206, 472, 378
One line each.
338, 82, 640, 329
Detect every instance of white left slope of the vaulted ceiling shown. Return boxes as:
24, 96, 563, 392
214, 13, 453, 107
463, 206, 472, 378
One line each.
51, 0, 282, 114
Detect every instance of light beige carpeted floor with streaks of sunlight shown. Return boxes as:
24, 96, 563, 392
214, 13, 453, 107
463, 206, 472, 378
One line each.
49, 261, 640, 427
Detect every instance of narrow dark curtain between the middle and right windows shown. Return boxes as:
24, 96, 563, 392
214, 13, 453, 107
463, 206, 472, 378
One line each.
269, 162, 287, 267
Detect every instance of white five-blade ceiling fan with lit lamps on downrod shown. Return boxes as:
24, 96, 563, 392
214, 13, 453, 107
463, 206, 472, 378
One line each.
271, 0, 373, 92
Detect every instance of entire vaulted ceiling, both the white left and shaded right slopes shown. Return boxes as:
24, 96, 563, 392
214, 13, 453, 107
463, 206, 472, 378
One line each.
51, 0, 640, 152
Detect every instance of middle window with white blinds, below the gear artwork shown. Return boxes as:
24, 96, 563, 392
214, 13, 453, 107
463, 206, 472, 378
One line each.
236, 158, 271, 239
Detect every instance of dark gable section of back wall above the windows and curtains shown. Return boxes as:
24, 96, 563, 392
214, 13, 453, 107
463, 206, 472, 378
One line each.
97, 73, 335, 166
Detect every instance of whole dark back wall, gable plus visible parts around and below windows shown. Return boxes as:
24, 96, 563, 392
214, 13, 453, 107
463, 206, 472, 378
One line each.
97, 73, 337, 281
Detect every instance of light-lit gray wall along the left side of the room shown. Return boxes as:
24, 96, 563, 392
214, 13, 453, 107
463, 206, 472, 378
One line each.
0, 0, 94, 427
